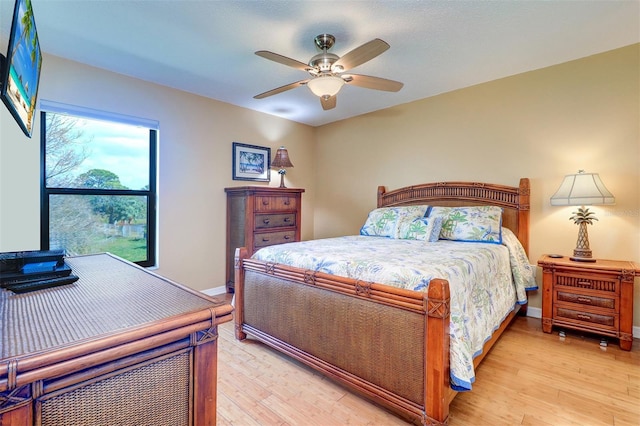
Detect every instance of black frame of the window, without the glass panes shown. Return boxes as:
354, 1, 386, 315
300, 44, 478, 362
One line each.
40, 106, 158, 267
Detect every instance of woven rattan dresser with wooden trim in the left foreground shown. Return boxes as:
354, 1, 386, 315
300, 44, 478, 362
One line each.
0, 254, 232, 426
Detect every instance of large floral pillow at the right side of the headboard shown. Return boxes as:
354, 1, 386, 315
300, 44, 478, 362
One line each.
430, 206, 502, 244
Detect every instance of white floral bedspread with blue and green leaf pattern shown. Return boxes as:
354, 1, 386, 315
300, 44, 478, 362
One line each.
253, 228, 537, 391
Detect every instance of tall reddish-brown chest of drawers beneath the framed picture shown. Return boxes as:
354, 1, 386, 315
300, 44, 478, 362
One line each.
225, 186, 304, 293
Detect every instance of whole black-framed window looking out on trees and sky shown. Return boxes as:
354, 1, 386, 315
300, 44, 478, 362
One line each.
40, 101, 157, 266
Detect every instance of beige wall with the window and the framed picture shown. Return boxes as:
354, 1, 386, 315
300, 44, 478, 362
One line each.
0, 56, 315, 290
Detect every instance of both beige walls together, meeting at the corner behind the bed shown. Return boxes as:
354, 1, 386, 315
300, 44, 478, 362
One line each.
0, 45, 640, 326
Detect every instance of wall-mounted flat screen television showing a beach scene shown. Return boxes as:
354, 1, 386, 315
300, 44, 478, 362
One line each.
0, 0, 42, 137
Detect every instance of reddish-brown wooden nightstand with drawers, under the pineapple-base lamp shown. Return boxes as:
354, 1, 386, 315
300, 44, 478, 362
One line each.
538, 255, 640, 351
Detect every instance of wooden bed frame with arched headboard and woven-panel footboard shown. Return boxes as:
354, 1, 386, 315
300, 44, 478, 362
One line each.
235, 178, 529, 425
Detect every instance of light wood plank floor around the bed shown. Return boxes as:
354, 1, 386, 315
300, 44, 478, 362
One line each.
218, 317, 640, 426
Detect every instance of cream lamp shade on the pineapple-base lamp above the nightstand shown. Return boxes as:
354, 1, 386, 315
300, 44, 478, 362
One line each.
551, 170, 616, 206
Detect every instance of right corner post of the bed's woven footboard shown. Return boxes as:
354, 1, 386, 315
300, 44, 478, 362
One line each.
423, 278, 450, 425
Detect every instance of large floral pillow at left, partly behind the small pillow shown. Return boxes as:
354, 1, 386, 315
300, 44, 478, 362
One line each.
360, 205, 429, 238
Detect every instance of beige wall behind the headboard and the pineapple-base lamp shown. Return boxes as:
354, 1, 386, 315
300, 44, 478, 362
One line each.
314, 44, 640, 326
